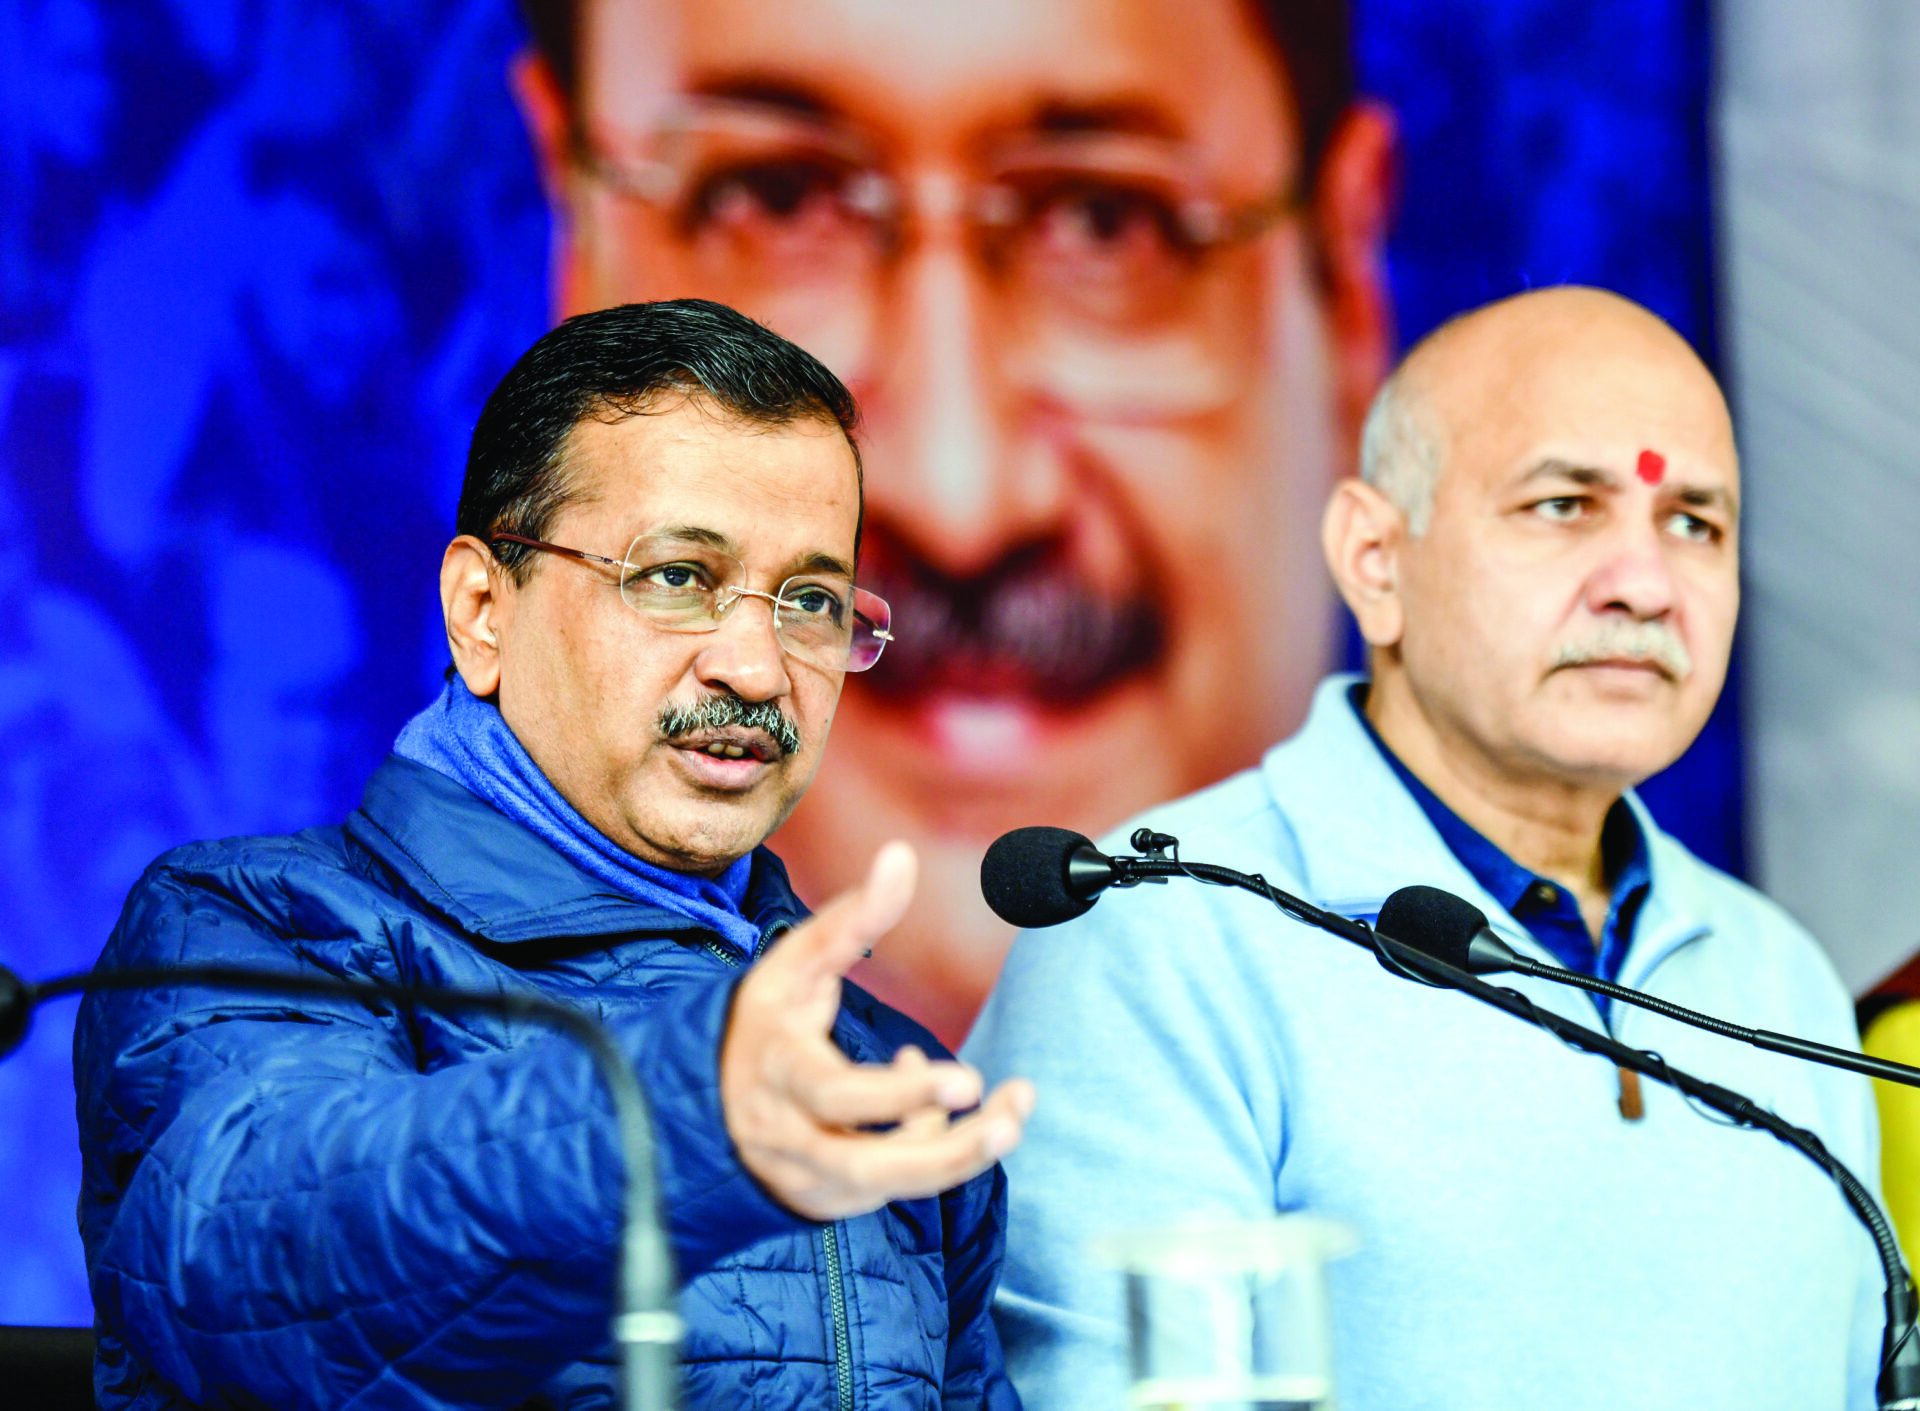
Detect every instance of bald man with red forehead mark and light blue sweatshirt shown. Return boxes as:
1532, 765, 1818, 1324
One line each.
968, 288, 1880, 1411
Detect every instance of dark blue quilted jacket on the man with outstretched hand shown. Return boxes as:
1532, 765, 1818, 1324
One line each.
75, 758, 1018, 1411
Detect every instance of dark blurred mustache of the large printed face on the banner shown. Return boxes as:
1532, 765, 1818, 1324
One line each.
862, 543, 1165, 705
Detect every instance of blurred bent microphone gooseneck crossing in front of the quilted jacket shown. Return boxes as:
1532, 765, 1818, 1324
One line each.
0, 966, 682, 1411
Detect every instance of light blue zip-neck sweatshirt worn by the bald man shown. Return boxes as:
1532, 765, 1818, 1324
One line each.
966, 678, 1882, 1411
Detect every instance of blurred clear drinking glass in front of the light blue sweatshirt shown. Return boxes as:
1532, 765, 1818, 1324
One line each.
1092, 1215, 1357, 1411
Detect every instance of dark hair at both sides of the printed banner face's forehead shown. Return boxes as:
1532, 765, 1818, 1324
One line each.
520, 0, 1354, 190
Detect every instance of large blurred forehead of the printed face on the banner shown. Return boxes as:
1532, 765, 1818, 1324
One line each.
580, 0, 1294, 177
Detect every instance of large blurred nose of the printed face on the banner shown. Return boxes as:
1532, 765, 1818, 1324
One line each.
868, 190, 1068, 576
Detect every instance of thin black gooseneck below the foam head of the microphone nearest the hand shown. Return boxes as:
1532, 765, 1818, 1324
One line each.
1098, 833, 1920, 1411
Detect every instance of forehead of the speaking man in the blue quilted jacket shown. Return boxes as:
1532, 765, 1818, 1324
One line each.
559, 399, 860, 564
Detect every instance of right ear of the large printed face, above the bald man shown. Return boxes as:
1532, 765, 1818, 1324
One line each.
1313, 98, 1400, 466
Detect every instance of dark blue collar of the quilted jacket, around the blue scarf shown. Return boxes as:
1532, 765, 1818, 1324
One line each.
348, 754, 806, 945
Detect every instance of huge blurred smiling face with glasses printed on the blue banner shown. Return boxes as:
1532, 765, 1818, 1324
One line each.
520, 0, 1392, 1040
